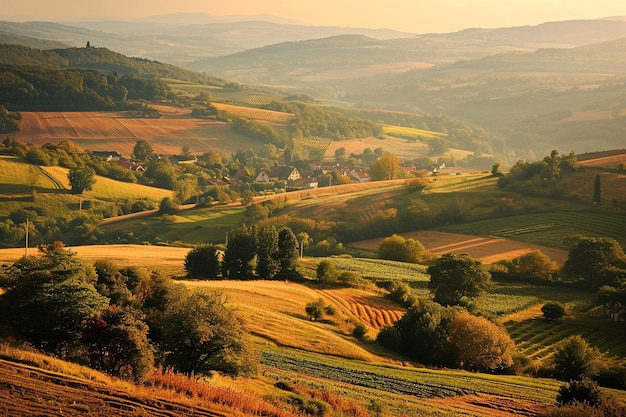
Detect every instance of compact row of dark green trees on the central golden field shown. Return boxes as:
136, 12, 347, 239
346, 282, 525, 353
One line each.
185, 224, 302, 280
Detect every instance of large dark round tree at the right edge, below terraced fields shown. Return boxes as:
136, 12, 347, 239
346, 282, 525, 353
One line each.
562, 237, 626, 290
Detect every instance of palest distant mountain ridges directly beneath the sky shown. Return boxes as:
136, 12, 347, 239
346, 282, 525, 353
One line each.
0, 14, 626, 73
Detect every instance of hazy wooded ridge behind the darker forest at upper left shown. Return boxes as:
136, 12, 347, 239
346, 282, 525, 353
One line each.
0, 43, 224, 85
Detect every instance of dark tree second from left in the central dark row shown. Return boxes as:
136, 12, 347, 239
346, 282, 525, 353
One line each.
222, 224, 257, 279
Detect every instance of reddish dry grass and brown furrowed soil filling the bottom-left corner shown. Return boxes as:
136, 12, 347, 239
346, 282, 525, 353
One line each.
0, 344, 294, 417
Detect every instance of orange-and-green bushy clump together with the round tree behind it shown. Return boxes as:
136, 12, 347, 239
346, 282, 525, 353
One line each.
377, 253, 514, 371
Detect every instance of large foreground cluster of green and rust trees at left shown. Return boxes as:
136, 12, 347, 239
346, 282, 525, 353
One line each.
0, 243, 254, 381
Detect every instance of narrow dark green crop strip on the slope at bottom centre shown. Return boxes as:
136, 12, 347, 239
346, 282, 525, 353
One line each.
261, 352, 468, 398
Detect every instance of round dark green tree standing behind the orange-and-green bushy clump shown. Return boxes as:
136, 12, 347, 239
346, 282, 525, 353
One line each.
427, 253, 491, 306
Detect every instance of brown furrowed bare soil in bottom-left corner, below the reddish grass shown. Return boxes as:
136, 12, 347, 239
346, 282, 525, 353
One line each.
0, 359, 225, 417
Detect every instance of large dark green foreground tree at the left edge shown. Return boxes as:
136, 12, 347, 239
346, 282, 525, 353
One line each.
0, 244, 109, 357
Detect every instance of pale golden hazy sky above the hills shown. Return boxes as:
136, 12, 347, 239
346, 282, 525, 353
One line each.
0, 0, 626, 33
